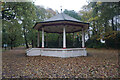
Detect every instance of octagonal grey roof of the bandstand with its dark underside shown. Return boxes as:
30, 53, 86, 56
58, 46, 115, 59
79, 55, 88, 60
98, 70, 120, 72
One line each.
33, 13, 89, 33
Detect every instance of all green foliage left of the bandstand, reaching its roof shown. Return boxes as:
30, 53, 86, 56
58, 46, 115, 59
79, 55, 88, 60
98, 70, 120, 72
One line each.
2, 2, 56, 49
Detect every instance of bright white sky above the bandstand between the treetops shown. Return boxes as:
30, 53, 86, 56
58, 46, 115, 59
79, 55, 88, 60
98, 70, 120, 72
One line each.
35, 0, 87, 12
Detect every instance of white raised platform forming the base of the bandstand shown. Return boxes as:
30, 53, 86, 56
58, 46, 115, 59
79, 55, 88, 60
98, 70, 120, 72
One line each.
26, 48, 87, 58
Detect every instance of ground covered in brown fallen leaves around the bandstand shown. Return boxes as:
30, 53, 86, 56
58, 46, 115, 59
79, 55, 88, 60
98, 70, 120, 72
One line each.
2, 48, 119, 78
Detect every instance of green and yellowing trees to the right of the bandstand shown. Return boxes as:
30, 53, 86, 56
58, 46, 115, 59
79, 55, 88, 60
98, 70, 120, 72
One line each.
79, 2, 120, 48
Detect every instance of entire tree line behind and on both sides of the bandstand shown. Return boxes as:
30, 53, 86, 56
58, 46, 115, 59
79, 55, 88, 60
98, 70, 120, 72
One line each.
2, 2, 120, 49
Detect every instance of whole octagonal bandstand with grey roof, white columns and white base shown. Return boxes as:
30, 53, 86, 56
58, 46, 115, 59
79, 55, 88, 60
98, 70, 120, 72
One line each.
26, 13, 89, 58
